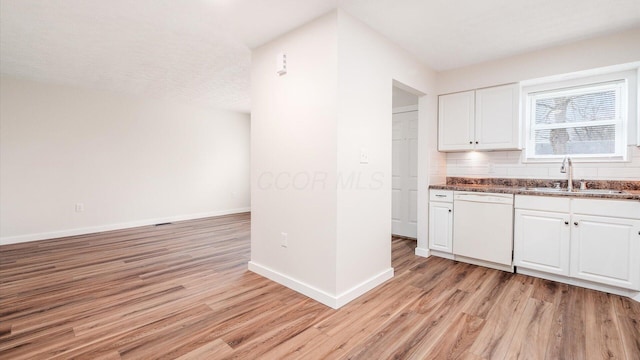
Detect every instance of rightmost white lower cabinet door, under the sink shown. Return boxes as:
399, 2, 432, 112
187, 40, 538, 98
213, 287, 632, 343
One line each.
571, 215, 640, 290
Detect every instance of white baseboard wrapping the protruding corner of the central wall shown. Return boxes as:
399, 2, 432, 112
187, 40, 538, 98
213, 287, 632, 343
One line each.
249, 261, 393, 309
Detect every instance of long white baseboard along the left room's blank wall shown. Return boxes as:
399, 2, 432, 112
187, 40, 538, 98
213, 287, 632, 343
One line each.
0, 207, 251, 245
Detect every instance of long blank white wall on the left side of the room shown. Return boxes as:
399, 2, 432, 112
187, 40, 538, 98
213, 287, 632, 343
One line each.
0, 77, 250, 244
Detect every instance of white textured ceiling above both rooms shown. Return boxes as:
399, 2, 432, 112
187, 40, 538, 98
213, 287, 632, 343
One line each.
0, 0, 640, 112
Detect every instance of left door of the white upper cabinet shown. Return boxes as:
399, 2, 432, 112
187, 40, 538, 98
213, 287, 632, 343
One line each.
438, 91, 475, 151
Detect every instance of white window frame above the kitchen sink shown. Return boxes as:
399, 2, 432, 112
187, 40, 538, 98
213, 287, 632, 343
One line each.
522, 72, 636, 162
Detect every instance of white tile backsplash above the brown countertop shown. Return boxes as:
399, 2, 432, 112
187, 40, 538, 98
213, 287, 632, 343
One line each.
446, 145, 640, 180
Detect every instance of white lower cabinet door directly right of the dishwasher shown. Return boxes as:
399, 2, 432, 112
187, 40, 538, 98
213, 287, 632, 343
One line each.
513, 209, 570, 276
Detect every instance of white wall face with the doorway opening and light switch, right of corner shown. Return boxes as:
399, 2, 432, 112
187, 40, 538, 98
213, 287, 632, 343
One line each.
337, 11, 435, 294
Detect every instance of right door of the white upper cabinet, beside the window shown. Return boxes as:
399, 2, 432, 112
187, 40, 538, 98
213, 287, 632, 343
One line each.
475, 84, 521, 150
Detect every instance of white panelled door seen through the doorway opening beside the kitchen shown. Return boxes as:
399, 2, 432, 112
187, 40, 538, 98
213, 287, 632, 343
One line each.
391, 111, 418, 238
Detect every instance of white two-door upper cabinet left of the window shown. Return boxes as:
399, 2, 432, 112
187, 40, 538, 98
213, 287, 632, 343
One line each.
438, 84, 521, 151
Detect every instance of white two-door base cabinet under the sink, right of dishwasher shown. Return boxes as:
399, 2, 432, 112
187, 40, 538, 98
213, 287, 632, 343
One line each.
514, 195, 640, 290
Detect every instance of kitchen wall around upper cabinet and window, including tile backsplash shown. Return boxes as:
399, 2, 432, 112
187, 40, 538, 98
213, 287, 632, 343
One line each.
437, 29, 640, 180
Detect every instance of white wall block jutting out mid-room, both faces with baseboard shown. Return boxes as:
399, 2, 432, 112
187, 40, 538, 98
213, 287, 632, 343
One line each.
249, 10, 436, 307
